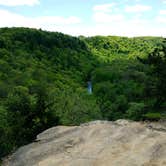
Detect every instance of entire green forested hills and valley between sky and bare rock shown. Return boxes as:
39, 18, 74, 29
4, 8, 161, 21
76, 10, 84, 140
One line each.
0, 28, 166, 160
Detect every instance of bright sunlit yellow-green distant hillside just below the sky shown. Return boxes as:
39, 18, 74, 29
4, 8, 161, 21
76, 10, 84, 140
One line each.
84, 36, 163, 62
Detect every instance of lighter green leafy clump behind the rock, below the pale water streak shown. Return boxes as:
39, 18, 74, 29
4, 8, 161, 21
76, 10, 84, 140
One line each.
52, 90, 102, 125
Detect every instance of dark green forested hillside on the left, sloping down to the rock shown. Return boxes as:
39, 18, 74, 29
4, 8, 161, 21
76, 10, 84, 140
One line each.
0, 28, 101, 156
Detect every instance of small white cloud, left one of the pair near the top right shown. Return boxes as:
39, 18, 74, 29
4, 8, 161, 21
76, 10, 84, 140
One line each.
93, 3, 115, 12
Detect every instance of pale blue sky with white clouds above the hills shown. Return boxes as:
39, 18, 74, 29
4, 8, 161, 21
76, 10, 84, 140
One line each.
0, 0, 166, 37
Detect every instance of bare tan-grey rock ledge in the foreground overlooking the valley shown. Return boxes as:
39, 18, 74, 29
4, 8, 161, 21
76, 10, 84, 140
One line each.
3, 120, 166, 166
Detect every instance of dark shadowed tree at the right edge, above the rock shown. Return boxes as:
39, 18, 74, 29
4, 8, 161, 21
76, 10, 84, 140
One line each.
142, 39, 166, 111
